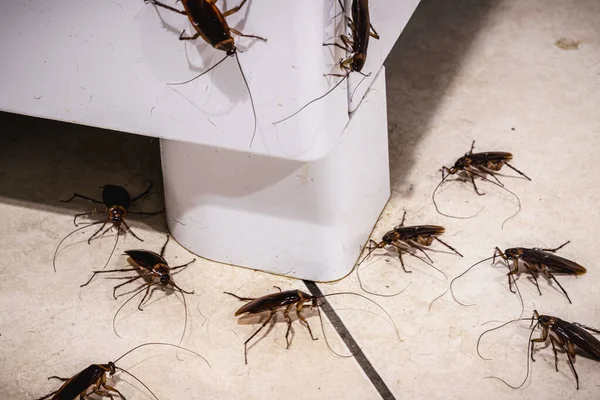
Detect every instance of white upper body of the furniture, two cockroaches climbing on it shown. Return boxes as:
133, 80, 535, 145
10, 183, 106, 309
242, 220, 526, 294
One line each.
0, 0, 417, 161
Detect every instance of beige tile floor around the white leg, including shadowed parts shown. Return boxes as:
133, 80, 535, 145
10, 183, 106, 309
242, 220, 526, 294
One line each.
0, 0, 600, 399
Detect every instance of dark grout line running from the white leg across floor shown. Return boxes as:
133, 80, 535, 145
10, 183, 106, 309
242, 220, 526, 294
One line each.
304, 280, 396, 400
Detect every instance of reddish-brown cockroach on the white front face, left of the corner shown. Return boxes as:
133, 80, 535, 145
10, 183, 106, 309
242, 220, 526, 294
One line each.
144, 0, 267, 147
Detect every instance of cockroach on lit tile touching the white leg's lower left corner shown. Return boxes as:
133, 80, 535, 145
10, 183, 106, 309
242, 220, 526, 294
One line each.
81, 235, 196, 343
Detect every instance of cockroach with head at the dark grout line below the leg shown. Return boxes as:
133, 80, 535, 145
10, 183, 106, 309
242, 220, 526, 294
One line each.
223, 288, 400, 364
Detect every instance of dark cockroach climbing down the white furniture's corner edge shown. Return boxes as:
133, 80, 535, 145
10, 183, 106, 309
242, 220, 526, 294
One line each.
273, 0, 379, 125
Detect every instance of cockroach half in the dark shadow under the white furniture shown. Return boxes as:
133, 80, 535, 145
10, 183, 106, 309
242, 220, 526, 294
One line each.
52, 183, 165, 272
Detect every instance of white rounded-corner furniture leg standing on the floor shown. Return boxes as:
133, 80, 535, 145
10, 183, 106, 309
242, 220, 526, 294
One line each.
161, 68, 390, 281
